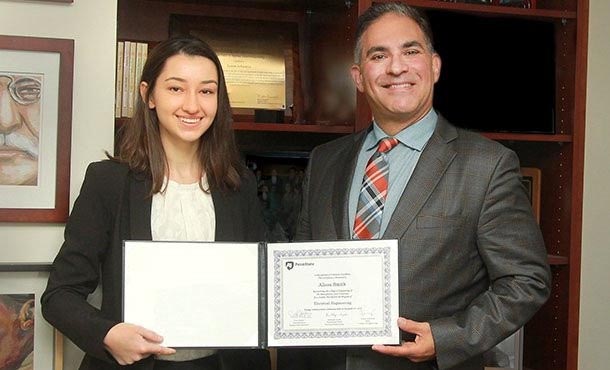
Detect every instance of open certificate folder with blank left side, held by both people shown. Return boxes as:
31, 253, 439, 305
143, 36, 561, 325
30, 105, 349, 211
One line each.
123, 240, 400, 348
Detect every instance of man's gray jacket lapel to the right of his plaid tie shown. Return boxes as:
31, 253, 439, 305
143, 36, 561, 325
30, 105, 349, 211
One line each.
383, 116, 457, 239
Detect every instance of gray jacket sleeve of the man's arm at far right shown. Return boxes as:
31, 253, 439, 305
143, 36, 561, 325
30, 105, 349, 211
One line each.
430, 150, 551, 369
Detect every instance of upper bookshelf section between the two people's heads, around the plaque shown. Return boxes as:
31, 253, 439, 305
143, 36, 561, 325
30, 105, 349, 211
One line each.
118, 0, 357, 134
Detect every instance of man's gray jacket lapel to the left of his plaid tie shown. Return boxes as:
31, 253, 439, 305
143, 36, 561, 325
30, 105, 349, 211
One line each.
332, 126, 372, 240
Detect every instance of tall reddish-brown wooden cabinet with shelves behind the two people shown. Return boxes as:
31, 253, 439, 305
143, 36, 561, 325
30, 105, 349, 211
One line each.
118, 0, 588, 370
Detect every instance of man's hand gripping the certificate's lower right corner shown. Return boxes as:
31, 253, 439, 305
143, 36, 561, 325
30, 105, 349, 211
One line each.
373, 317, 436, 362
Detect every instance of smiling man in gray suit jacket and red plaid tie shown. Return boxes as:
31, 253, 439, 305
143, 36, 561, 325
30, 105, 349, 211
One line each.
279, 3, 550, 370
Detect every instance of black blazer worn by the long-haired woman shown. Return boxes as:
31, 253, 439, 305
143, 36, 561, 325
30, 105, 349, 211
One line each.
41, 160, 269, 370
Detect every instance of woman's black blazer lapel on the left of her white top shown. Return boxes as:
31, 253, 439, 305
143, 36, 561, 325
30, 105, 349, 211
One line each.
128, 173, 152, 240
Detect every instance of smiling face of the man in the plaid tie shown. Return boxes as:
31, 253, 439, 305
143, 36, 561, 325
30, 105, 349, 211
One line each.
351, 13, 441, 134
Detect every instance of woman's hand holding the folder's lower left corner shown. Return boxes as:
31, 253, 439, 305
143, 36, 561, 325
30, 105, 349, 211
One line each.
104, 323, 176, 365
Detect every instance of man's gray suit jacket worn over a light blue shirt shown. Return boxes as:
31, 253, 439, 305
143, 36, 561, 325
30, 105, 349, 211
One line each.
288, 116, 551, 370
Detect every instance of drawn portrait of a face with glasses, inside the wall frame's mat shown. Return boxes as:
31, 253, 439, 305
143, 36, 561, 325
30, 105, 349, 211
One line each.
0, 72, 41, 185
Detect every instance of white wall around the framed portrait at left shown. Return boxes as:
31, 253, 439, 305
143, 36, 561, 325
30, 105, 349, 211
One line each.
0, 0, 117, 262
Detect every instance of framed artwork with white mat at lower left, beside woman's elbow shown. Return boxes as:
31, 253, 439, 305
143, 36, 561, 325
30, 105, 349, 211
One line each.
0, 264, 63, 370
